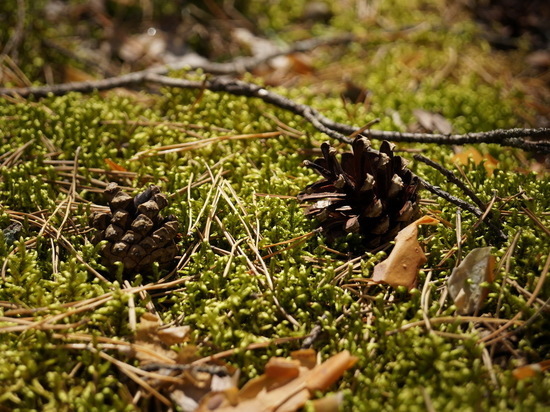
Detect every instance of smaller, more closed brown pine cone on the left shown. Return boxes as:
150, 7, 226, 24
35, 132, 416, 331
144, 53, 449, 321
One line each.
90, 183, 178, 276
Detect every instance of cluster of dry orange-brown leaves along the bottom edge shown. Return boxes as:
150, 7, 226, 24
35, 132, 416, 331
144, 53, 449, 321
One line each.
104, 313, 358, 412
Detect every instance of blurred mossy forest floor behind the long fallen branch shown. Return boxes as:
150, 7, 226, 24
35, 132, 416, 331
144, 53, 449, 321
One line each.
0, 0, 550, 130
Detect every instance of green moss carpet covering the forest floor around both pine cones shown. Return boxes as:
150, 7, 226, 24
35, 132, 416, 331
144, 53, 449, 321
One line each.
0, 1, 550, 411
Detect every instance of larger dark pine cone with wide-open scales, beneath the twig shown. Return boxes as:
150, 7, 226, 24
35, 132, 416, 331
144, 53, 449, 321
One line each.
298, 136, 419, 250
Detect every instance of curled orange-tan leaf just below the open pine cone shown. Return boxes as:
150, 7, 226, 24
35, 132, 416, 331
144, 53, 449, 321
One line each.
372, 216, 439, 289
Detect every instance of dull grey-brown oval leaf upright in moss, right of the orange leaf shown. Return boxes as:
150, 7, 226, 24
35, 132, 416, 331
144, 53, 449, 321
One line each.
447, 247, 495, 315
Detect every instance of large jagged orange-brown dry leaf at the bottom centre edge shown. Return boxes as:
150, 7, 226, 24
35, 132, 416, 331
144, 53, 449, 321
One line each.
197, 351, 358, 412
